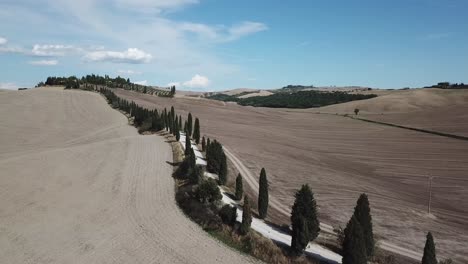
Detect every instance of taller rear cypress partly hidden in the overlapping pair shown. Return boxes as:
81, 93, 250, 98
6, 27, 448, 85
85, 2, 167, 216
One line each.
354, 193, 374, 259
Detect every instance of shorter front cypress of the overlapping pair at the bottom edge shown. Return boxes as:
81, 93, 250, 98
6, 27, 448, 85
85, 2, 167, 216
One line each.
342, 215, 367, 264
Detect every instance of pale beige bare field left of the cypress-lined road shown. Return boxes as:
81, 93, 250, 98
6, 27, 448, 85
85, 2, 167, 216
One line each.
0, 88, 251, 264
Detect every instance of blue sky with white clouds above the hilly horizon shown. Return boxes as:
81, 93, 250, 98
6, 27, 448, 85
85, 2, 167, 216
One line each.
0, 0, 468, 91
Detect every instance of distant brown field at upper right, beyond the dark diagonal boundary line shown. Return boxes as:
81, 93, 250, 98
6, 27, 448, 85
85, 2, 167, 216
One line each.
317, 89, 468, 136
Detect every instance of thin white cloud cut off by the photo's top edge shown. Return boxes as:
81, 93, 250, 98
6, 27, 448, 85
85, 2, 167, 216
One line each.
116, 0, 198, 13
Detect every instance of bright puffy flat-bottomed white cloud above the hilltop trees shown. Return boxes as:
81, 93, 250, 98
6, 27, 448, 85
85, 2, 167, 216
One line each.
85, 48, 152, 63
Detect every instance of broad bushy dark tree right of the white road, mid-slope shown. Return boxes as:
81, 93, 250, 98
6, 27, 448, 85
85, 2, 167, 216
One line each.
206, 140, 227, 185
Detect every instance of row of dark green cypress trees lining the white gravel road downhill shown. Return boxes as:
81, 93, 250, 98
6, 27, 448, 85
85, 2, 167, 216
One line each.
99, 88, 438, 264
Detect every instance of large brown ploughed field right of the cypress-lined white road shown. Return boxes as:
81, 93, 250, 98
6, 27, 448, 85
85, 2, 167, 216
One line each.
116, 90, 468, 262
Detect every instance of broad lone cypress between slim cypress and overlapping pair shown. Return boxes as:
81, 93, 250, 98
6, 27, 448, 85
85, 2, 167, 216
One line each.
291, 184, 320, 254
